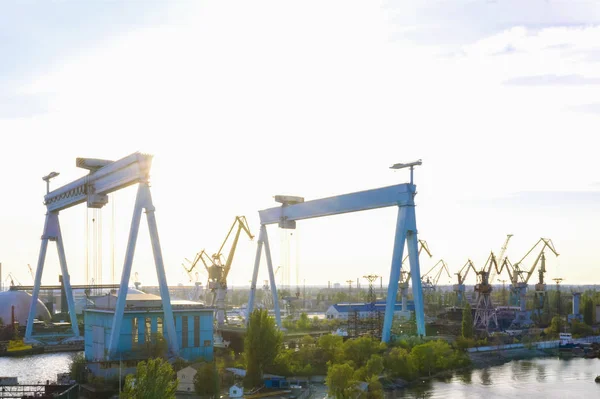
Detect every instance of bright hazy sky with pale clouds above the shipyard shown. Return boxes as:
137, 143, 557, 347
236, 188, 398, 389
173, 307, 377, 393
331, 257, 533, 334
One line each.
0, 0, 600, 294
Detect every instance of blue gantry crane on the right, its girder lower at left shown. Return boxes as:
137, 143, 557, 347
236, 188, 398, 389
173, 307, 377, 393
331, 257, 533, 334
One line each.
248, 169, 425, 342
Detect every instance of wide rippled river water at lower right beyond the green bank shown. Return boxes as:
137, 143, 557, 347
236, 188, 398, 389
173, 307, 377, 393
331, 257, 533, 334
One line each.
389, 358, 600, 399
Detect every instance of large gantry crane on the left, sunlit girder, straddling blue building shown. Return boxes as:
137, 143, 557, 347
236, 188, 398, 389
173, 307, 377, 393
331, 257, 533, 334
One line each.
25, 152, 179, 359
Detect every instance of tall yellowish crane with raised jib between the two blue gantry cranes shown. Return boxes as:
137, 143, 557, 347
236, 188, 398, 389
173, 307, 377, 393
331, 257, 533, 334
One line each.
208, 216, 254, 327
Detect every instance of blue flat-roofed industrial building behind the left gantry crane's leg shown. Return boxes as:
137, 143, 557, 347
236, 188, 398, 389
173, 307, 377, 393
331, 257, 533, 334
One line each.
84, 293, 214, 377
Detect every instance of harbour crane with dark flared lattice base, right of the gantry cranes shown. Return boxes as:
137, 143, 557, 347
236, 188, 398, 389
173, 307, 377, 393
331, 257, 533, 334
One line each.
473, 252, 500, 332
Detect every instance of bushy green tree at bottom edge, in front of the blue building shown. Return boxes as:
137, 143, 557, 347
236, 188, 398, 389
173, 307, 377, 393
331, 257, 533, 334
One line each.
120, 358, 177, 399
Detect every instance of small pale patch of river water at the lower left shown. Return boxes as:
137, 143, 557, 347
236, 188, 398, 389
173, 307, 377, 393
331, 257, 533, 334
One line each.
0, 352, 78, 384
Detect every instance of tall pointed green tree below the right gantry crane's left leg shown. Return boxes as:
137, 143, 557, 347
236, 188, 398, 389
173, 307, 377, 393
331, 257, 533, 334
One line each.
244, 309, 283, 388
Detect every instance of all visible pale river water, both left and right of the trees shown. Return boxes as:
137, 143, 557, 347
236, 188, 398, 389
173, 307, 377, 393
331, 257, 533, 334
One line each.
0, 353, 600, 399
